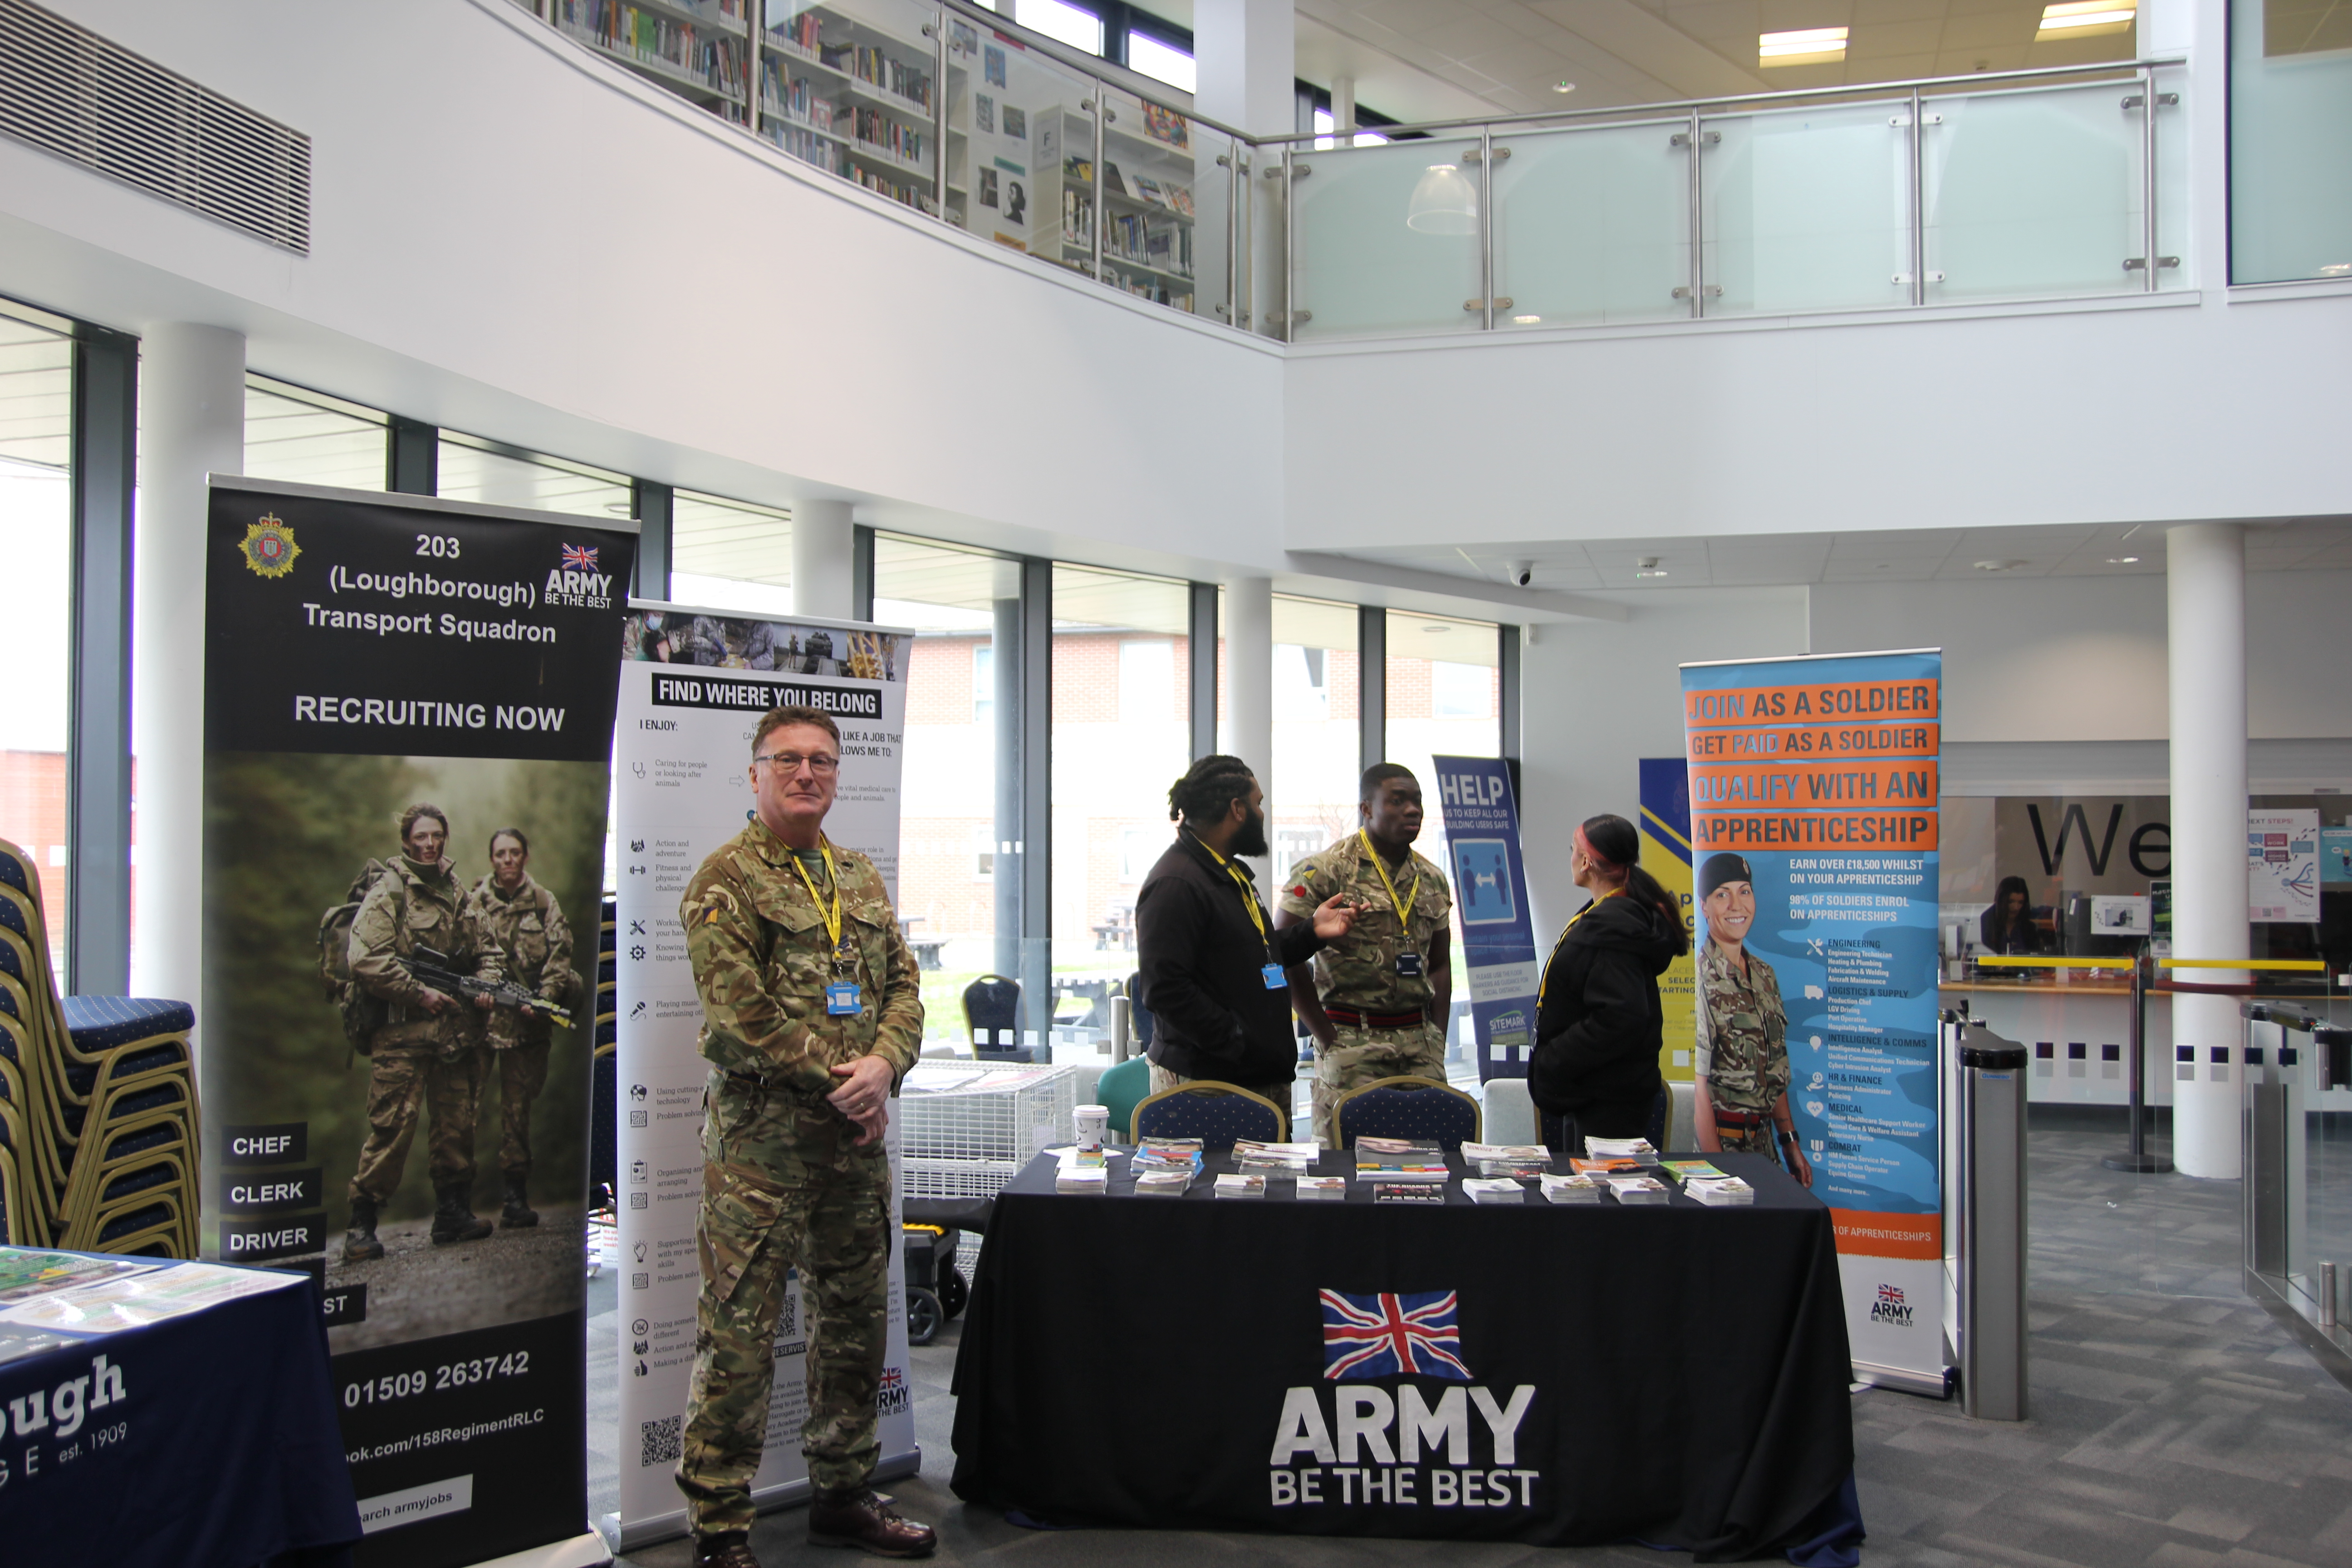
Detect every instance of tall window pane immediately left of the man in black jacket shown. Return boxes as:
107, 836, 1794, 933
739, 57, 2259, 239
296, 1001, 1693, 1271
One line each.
1054, 567, 1192, 1049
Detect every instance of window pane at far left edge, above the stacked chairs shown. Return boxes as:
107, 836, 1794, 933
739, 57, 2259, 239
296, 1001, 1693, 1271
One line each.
0, 306, 73, 971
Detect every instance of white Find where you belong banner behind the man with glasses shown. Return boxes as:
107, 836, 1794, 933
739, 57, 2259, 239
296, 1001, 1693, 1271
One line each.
614, 599, 920, 1549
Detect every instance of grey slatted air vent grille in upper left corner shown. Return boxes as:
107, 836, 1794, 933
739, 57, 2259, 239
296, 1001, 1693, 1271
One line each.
0, 0, 310, 256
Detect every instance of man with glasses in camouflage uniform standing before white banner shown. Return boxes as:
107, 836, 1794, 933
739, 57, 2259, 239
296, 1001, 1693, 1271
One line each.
677, 708, 936, 1568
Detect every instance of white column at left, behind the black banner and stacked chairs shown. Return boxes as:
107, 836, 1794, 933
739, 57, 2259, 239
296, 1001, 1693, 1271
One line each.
132, 322, 245, 1029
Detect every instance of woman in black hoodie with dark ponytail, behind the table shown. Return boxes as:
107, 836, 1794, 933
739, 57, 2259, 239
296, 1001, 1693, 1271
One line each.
1526, 813, 1691, 1145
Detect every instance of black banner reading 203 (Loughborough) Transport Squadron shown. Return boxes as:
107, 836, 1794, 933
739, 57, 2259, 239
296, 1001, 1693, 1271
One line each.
200, 477, 637, 1568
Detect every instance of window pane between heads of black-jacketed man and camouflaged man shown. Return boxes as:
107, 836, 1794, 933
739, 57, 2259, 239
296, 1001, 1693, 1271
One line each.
1265, 595, 1362, 882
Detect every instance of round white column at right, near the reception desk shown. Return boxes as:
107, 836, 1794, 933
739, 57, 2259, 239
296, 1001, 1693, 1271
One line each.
2152, 522, 2249, 1178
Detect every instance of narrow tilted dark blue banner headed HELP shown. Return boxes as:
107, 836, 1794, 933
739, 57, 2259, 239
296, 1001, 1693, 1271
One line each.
1430, 757, 1541, 1084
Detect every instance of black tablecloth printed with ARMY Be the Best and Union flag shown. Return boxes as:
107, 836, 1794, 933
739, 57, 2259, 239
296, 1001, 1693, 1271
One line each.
953, 1154, 1858, 1561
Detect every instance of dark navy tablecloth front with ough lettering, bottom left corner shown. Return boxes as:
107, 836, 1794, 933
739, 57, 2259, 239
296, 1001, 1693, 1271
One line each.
0, 1279, 360, 1568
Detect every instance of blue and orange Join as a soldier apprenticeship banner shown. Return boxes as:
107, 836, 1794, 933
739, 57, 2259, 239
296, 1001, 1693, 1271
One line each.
1682, 649, 1945, 1385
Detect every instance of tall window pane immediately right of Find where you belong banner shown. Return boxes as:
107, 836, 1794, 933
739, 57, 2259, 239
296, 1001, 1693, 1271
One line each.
875, 534, 1042, 1051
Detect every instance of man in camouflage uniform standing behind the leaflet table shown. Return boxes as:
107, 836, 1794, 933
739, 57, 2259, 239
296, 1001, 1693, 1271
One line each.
1275, 762, 1454, 1150
